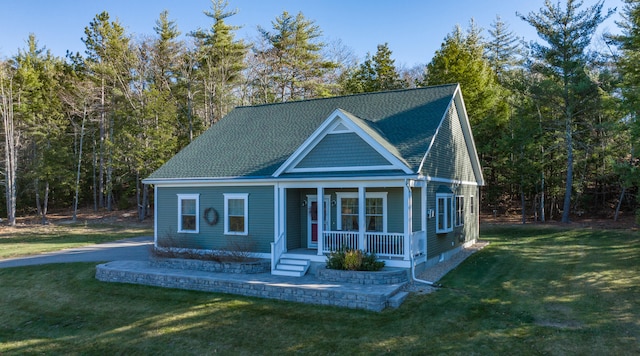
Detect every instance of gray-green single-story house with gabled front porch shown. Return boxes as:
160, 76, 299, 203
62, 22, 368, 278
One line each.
144, 84, 484, 275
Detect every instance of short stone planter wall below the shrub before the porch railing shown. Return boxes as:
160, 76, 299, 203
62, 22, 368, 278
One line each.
316, 268, 409, 285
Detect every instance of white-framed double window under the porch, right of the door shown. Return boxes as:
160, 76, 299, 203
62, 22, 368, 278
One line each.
336, 192, 387, 232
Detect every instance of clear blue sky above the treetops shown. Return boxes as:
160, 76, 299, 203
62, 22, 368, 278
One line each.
0, 0, 622, 67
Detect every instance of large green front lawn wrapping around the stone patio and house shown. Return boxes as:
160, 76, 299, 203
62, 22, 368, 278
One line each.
0, 227, 640, 355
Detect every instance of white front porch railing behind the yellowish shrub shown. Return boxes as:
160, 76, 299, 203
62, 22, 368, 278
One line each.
322, 231, 407, 257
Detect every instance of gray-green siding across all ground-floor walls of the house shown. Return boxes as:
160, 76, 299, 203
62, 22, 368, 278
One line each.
157, 182, 470, 258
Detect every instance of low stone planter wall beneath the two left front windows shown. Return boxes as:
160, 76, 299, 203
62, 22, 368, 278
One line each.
150, 258, 271, 274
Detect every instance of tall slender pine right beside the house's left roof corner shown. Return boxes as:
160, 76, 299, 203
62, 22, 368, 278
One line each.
118, 11, 182, 221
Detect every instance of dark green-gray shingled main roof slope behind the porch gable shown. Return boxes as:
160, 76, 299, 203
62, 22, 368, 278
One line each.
147, 84, 457, 180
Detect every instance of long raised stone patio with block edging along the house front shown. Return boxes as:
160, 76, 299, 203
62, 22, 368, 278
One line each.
96, 261, 406, 311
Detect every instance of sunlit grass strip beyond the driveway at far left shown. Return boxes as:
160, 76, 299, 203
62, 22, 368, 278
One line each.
0, 224, 153, 259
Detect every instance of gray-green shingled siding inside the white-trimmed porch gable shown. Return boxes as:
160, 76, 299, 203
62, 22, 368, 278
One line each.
295, 132, 390, 168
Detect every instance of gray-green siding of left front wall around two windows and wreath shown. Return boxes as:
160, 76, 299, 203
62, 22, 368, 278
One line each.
156, 186, 274, 253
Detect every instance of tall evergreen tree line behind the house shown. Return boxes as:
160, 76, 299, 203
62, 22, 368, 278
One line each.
0, 0, 640, 225
